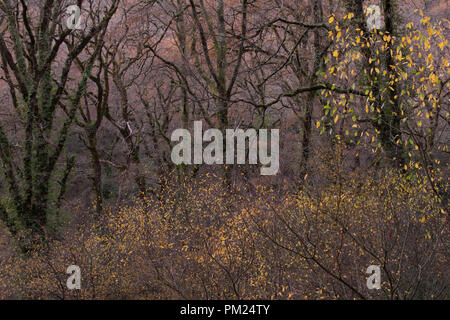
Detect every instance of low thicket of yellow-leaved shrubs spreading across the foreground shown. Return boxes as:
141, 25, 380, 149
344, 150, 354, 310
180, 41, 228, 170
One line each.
0, 144, 449, 299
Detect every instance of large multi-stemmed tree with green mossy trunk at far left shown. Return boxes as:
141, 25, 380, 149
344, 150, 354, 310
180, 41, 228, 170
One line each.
0, 0, 119, 239
